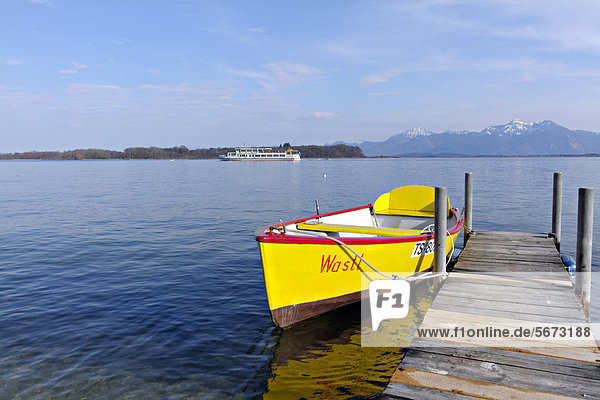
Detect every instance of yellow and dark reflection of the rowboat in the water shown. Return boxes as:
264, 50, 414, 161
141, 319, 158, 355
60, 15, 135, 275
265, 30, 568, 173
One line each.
263, 281, 436, 399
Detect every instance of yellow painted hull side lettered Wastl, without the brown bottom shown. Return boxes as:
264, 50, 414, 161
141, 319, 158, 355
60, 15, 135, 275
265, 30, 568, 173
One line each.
259, 233, 458, 310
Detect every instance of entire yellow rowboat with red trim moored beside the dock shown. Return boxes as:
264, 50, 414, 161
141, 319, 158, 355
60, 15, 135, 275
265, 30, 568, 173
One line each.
254, 185, 463, 329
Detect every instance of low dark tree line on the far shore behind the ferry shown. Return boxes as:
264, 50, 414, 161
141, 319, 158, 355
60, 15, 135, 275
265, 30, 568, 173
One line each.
0, 143, 364, 160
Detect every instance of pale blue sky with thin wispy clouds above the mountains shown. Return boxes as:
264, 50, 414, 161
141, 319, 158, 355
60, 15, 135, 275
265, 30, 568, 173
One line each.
0, 0, 600, 153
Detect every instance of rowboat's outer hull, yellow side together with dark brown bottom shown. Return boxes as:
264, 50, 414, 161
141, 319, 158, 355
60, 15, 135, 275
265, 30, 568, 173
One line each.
257, 228, 462, 329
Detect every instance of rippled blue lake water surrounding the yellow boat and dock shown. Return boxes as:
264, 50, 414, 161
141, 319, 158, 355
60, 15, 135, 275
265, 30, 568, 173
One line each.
0, 158, 600, 399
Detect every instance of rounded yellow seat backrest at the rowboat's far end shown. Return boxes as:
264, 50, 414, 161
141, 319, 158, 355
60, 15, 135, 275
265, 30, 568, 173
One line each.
373, 185, 450, 217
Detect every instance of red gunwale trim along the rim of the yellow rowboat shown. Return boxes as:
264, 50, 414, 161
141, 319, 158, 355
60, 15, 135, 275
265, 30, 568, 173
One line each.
254, 204, 463, 245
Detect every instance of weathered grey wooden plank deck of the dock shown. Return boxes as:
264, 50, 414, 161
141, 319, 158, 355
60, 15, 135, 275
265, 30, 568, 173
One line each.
383, 231, 600, 400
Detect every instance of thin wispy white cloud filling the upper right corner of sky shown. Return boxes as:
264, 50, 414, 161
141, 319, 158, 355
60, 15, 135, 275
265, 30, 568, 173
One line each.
381, 0, 600, 53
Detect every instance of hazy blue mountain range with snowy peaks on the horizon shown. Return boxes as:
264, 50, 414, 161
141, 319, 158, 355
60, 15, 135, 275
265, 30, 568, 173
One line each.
335, 119, 600, 157
